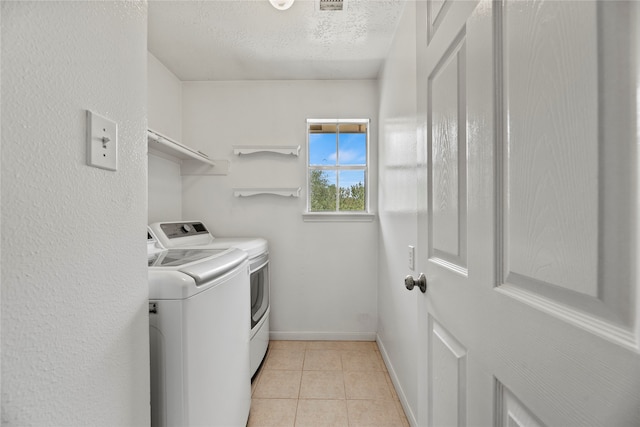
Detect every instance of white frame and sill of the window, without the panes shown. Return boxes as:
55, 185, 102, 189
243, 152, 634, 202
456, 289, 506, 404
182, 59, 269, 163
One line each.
303, 119, 375, 222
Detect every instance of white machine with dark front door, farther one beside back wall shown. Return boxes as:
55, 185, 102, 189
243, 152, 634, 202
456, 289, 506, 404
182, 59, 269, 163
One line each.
149, 221, 271, 376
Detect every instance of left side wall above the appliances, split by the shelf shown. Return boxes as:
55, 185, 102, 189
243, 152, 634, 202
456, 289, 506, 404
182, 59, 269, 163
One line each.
147, 53, 182, 224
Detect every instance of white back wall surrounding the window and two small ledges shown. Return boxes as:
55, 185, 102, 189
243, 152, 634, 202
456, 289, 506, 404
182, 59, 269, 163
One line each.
182, 81, 378, 339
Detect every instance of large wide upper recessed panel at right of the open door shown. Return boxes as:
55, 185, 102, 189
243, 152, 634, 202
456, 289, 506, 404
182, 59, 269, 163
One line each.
494, 2, 639, 351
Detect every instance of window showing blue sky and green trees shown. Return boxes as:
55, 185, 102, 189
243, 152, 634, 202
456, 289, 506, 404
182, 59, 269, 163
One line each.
307, 119, 369, 214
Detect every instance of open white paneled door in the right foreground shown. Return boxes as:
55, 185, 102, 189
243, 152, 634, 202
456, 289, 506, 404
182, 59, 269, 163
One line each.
412, 0, 640, 427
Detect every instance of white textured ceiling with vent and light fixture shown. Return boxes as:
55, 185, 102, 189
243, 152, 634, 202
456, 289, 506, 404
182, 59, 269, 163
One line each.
148, 0, 405, 81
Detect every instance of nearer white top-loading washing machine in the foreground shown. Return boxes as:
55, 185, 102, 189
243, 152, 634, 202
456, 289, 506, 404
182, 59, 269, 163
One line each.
147, 233, 251, 427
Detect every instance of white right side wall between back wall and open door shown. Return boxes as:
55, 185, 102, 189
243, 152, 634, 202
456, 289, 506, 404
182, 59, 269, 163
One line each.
378, 1, 426, 425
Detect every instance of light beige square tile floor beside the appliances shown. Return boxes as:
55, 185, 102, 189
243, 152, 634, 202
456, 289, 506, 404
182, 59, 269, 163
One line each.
248, 341, 409, 427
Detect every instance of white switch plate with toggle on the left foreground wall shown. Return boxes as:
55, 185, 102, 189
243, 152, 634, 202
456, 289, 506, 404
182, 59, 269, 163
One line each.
87, 110, 118, 171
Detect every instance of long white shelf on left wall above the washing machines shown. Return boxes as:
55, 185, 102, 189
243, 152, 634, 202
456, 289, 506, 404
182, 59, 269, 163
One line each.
147, 129, 230, 175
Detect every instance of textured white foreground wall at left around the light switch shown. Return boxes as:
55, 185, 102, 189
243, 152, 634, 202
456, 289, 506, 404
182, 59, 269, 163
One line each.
1, 1, 149, 426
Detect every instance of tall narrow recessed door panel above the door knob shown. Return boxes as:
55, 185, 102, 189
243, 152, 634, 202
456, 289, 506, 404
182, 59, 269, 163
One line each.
427, 27, 467, 276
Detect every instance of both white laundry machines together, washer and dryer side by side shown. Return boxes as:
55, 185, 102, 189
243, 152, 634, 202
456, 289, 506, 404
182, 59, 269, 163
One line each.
147, 221, 270, 426
